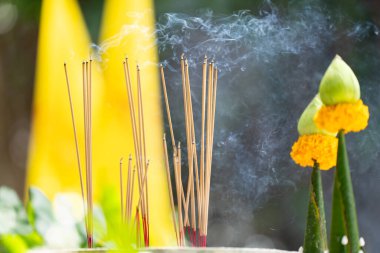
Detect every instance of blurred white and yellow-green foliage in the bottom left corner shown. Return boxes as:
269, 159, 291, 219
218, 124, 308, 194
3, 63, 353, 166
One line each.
0, 187, 134, 253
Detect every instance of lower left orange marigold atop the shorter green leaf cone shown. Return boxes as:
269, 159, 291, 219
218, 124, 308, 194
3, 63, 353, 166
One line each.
290, 134, 338, 170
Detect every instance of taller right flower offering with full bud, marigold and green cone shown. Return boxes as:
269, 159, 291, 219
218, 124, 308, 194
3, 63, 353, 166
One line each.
315, 56, 369, 253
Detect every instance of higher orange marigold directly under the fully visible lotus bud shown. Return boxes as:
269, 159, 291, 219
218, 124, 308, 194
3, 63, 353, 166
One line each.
314, 100, 369, 133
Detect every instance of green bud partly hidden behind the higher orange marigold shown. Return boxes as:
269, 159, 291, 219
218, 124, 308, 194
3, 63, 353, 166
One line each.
297, 94, 336, 136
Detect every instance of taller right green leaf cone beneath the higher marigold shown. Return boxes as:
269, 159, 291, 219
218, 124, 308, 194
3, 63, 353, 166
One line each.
330, 131, 360, 253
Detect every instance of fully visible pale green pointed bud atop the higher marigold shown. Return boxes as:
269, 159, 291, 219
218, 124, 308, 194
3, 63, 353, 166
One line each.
319, 55, 360, 105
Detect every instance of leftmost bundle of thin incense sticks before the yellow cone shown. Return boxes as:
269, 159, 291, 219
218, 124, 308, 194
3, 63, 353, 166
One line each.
64, 59, 94, 248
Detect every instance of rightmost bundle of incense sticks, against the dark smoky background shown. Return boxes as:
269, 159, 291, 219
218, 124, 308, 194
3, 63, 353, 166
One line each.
160, 55, 218, 247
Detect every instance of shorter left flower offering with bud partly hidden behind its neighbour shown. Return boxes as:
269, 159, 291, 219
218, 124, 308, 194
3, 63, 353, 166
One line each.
290, 95, 338, 253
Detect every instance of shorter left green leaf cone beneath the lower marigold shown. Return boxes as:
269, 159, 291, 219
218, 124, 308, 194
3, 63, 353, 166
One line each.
303, 163, 328, 253
